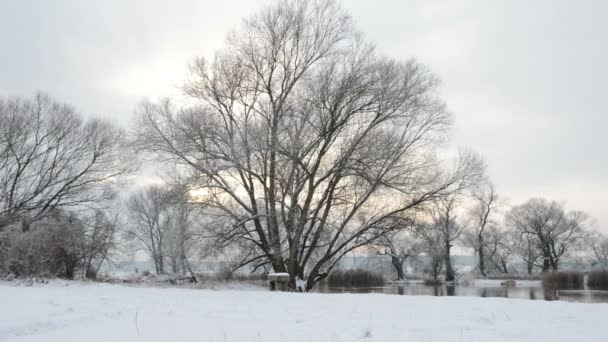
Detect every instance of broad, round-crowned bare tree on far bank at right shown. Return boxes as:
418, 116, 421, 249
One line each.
506, 198, 588, 272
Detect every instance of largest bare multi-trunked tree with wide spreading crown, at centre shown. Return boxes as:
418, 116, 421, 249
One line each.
135, 0, 480, 290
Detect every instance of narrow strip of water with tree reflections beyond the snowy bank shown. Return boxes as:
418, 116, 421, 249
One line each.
315, 284, 608, 303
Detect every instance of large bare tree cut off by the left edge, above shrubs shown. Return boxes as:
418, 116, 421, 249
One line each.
0, 94, 129, 230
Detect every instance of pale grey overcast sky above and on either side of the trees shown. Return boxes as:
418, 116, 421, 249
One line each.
0, 0, 608, 232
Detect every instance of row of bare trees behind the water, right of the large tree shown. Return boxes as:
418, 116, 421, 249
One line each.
374, 184, 608, 281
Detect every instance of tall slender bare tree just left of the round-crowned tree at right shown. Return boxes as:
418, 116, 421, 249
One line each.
464, 183, 500, 276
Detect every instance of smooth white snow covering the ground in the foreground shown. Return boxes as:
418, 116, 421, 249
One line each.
0, 282, 608, 342
